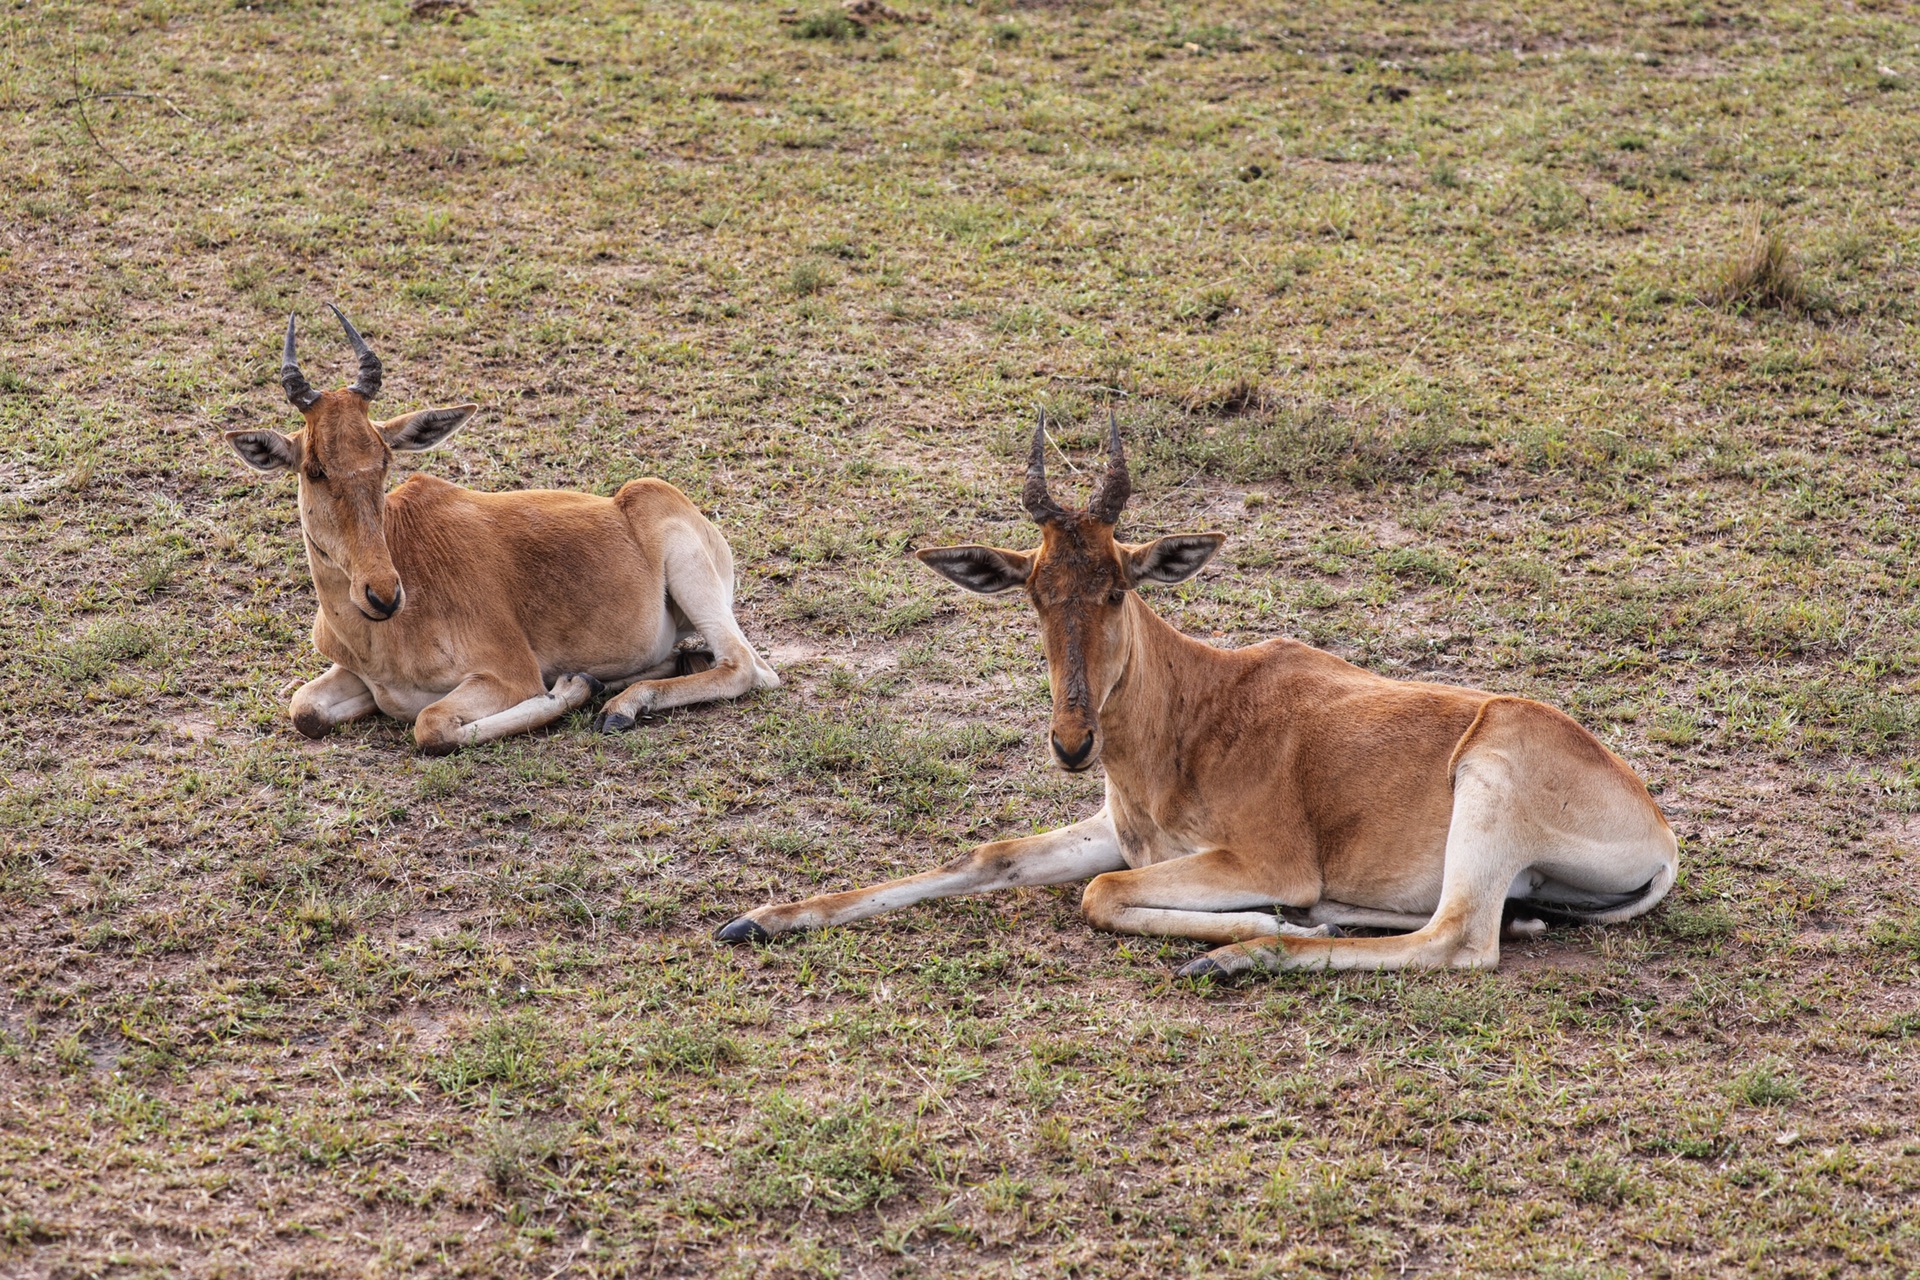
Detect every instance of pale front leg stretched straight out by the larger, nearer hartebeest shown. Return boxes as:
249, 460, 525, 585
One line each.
714, 810, 1127, 942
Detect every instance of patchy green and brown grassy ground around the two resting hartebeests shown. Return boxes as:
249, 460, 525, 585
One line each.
0, 0, 1920, 1276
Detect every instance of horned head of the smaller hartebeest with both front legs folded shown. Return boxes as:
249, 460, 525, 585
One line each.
227, 312, 478, 622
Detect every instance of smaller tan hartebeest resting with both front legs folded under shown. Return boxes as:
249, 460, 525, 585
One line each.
227, 307, 780, 754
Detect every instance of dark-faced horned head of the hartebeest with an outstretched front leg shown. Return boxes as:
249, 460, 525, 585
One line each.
914, 411, 1227, 773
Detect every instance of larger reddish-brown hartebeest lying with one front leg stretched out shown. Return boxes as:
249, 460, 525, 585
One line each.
718, 416, 1678, 975
